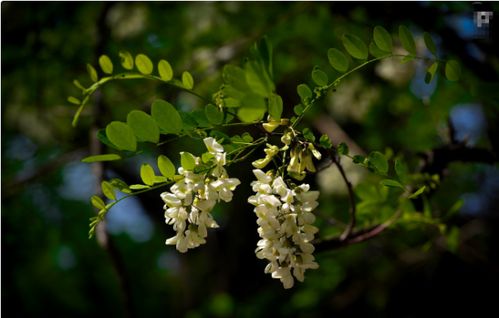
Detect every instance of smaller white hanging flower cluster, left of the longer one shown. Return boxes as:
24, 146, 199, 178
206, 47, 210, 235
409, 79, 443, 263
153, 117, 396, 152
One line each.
161, 137, 241, 253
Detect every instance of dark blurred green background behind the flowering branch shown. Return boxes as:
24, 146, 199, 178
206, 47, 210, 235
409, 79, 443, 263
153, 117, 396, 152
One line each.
1, 2, 499, 317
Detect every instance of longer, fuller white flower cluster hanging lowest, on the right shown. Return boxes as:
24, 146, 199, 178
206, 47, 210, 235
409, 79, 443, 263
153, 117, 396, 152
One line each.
248, 169, 319, 288
